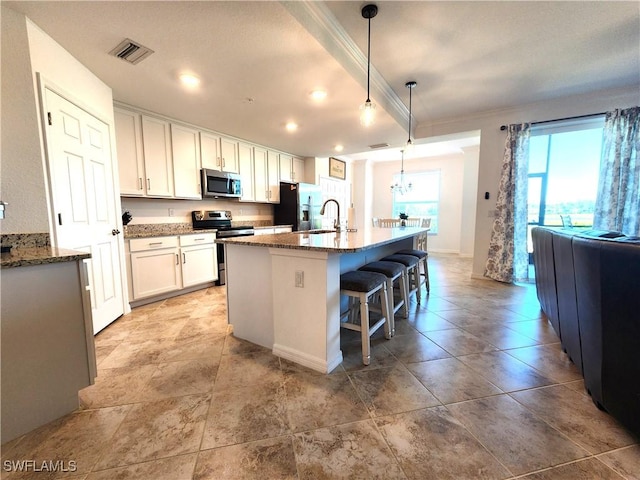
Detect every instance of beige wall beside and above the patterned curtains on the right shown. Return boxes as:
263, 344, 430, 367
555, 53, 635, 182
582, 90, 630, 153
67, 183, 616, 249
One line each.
415, 86, 640, 276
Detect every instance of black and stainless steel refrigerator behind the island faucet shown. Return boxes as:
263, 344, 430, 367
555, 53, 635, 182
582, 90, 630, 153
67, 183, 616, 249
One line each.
273, 182, 322, 232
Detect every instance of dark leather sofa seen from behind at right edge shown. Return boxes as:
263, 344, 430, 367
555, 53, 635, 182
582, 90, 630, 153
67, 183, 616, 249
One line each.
532, 227, 640, 434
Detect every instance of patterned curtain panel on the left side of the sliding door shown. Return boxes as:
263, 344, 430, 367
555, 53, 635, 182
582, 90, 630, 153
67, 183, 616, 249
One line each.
484, 123, 530, 282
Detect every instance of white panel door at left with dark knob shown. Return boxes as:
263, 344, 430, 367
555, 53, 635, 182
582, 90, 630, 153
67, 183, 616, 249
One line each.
45, 88, 124, 334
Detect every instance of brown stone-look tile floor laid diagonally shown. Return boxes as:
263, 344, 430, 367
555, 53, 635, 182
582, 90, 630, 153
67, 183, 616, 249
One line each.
2, 255, 640, 480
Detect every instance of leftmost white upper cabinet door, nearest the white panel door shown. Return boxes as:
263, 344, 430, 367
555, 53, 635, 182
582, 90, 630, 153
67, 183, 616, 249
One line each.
114, 108, 146, 197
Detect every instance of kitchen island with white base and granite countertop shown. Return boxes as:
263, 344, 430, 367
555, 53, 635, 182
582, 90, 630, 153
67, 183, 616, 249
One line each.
216, 227, 427, 373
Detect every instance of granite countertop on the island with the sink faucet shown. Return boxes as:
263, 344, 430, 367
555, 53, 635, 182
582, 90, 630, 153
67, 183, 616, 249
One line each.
216, 227, 429, 253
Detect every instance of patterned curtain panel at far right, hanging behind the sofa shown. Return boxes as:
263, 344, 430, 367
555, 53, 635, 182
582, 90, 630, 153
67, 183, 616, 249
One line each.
593, 107, 640, 236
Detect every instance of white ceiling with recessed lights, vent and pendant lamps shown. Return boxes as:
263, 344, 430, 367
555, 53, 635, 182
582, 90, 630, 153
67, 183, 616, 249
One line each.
2, 0, 640, 162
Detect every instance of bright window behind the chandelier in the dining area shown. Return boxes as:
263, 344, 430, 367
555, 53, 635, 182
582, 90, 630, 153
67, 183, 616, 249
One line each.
392, 170, 440, 233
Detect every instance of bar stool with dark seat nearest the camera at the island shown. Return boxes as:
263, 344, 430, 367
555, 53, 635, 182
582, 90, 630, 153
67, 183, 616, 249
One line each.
340, 270, 392, 365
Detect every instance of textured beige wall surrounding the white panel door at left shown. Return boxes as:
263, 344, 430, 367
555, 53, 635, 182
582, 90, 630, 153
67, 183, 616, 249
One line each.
0, 7, 120, 233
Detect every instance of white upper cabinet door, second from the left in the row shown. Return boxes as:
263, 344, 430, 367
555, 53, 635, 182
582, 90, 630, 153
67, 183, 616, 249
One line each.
142, 115, 174, 197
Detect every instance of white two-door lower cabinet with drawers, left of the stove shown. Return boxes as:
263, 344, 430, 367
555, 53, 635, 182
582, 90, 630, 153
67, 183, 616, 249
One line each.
129, 233, 218, 301
